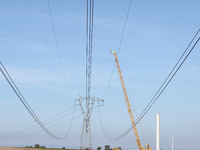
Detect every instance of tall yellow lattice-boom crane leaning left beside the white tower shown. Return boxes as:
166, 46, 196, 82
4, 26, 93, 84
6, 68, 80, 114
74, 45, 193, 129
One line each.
110, 49, 151, 150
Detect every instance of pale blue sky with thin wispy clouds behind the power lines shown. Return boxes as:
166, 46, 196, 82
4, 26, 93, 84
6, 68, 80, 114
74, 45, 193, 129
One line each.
0, 0, 200, 150
